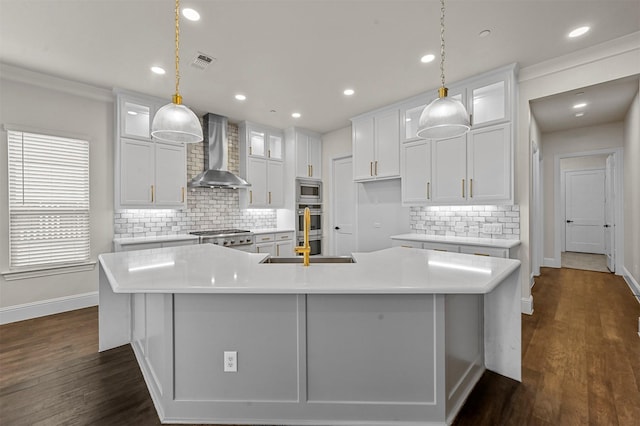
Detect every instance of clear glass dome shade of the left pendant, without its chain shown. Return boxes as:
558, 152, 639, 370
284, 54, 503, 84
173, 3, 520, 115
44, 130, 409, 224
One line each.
151, 103, 203, 143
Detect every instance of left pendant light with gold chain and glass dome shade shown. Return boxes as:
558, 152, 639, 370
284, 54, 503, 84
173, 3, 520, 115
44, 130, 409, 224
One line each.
151, 0, 203, 143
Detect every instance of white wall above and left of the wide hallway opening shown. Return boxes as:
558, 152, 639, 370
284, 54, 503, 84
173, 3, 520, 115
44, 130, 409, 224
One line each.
515, 33, 640, 311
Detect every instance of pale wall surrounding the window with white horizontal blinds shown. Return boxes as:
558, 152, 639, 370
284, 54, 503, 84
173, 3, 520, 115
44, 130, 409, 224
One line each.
0, 65, 114, 308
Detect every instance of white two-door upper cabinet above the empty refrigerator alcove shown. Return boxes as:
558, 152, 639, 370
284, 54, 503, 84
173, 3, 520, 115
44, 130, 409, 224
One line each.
351, 108, 400, 181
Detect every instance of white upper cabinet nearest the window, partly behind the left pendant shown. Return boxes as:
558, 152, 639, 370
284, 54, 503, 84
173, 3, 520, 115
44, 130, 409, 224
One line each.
114, 90, 187, 209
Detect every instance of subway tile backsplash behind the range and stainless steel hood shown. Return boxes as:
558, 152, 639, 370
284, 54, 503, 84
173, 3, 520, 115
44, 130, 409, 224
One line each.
114, 123, 277, 238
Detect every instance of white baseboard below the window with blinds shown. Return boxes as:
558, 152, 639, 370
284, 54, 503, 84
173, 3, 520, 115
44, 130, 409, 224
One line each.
0, 291, 98, 324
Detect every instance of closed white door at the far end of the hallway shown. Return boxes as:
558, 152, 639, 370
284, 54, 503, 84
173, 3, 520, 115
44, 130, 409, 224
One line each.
565, 169, 605, 254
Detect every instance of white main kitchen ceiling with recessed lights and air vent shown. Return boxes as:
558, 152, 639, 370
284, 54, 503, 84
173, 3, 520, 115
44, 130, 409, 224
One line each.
0, 0, 640, 133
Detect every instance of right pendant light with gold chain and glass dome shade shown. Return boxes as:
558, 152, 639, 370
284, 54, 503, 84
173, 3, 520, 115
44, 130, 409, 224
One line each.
416, 0, 470, 139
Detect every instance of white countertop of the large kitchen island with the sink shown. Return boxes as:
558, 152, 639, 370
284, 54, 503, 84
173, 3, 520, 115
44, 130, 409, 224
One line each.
98, 244, 520, 294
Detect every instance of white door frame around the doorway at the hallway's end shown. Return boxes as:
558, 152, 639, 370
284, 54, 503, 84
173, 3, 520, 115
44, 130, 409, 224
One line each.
546, 148, 624, 275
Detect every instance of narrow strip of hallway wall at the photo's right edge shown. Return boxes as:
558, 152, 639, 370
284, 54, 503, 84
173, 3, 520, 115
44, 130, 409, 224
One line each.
623, 86, 640, 283
